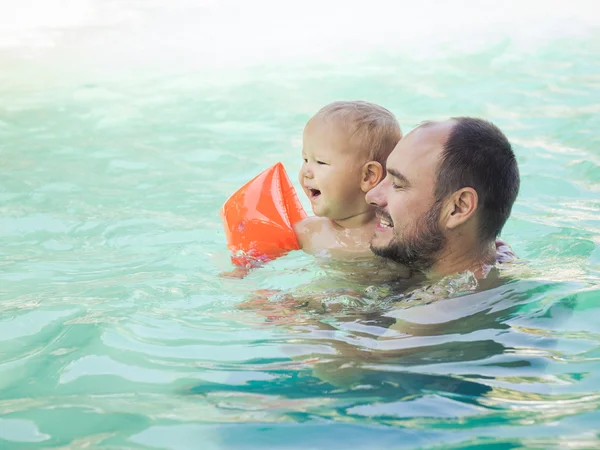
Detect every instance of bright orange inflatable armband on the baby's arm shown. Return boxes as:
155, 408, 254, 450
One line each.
221, 163, 306, 267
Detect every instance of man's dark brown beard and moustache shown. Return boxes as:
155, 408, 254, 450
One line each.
371, 202, 446, 271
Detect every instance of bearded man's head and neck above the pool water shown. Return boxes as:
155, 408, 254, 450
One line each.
366, 117, 519, 278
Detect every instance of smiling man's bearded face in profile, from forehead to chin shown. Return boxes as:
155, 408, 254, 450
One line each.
366, 122, 453, 270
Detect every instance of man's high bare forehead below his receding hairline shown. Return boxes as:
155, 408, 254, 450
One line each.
387, 121, 454, 179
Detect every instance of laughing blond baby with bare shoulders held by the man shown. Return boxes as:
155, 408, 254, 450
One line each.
295, 101, 402, 259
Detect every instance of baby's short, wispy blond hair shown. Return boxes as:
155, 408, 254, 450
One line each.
311, 101, 402, 169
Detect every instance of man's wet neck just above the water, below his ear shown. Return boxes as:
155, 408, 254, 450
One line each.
425, 243, 496, 280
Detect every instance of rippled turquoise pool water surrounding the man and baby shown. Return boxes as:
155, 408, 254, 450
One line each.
0, 0, 600, 449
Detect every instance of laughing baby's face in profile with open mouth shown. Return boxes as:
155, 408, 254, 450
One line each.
299, 119, 368, 220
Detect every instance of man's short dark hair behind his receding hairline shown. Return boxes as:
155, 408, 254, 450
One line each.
435, 117, 520, 241
